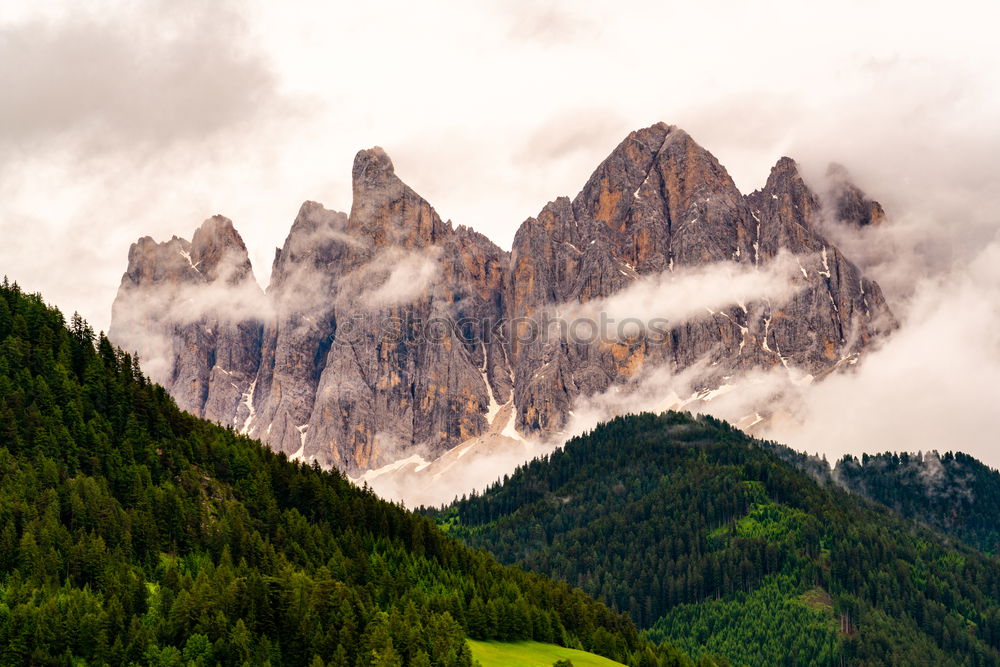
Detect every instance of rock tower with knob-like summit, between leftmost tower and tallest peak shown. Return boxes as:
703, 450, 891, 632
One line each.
232, 148, 509, 472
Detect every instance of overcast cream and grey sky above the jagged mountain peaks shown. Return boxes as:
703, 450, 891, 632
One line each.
0, 0, 1000, 464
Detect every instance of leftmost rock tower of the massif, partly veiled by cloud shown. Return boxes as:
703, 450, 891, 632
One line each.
109, 216, 264, 425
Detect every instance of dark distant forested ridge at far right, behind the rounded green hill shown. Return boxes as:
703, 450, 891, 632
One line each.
833, 452, 1000, 554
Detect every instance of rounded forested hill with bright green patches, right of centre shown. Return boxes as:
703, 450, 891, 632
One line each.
433, 413, 1000, 665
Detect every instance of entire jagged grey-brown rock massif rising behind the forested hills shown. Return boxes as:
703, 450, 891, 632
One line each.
113, 123, 895, 474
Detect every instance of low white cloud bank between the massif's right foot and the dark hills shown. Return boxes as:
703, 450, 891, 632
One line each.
566, 230, 1000, 467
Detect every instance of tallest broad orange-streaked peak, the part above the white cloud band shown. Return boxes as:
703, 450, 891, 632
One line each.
511, 123, 752, 328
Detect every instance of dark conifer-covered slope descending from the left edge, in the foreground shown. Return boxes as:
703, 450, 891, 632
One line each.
0, 281, 687, 666
